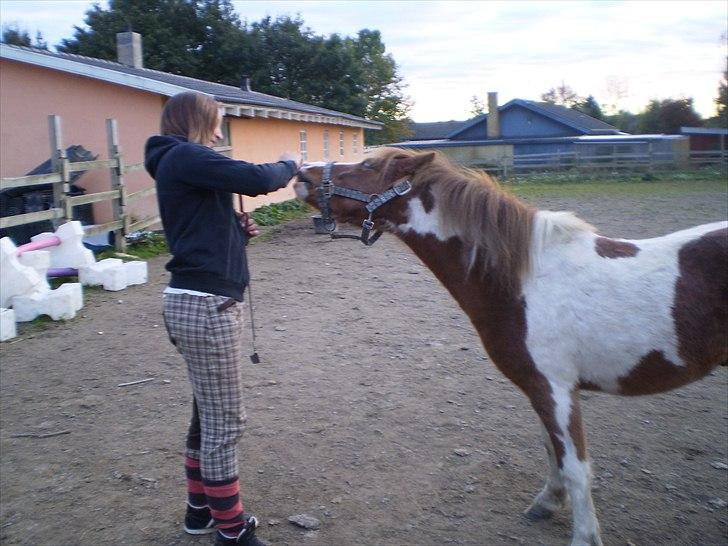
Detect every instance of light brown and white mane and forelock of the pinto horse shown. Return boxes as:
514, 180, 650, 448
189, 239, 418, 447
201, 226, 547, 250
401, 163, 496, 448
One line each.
373, 148, 593, 287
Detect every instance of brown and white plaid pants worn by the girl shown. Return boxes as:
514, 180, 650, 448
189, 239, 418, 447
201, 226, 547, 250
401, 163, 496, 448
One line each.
164, 294, 245, 482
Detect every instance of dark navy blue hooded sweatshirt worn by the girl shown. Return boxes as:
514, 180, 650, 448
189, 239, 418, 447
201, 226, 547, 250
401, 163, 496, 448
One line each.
144, 136, 296, 301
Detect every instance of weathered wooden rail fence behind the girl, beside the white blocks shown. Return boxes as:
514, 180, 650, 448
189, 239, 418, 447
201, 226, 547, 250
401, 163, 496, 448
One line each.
0, 115, 159, 251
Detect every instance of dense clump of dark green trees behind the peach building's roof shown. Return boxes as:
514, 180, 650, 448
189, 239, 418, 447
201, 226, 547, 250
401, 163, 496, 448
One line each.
59, 0, 411, 142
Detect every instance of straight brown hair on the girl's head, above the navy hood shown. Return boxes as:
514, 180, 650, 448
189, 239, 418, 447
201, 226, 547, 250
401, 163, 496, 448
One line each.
159, 91, 220, 146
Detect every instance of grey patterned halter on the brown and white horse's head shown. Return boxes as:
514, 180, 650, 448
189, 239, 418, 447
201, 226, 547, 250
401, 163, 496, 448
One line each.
300, 161, 412, 246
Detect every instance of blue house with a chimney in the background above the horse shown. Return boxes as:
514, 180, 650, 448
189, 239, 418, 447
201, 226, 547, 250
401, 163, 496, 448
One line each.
392, 93, 688, 166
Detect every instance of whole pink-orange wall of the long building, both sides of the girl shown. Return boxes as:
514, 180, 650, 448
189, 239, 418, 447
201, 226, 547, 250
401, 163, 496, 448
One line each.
0, 60, 364, 221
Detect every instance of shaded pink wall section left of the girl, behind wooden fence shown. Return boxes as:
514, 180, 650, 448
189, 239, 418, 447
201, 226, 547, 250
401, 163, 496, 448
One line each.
0, 60, 163, 223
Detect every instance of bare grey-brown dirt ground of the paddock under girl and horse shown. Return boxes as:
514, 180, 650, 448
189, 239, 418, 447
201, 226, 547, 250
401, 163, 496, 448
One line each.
0, 187, 728, 546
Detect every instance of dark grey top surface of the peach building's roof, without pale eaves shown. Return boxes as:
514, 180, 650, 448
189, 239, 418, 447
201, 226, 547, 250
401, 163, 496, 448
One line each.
2, 44, 383, 126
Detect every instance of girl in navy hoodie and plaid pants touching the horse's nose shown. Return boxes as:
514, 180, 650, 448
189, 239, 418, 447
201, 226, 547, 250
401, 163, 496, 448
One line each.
145, 92, 300, 546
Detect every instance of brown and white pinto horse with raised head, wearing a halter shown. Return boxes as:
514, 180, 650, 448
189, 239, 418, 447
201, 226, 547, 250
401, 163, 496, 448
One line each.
294, 148, 728, 546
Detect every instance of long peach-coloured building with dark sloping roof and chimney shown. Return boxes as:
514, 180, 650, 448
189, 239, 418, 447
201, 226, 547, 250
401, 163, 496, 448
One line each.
0, 33, 382, 223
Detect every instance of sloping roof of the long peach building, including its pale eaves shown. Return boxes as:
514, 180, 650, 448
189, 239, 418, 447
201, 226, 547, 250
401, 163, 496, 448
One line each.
0, 44, 384, 129
